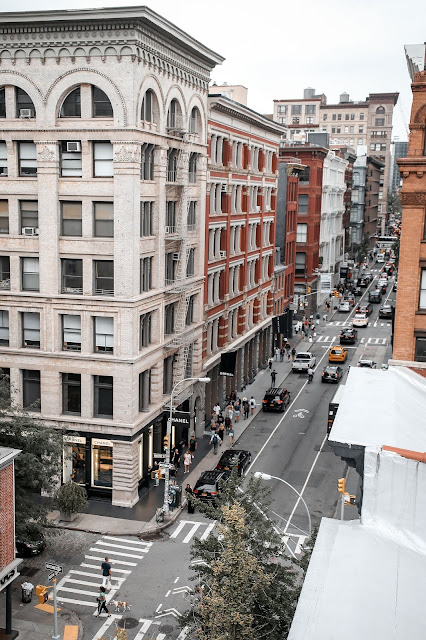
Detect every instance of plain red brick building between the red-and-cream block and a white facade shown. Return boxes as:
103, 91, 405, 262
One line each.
279, 144, 328, 314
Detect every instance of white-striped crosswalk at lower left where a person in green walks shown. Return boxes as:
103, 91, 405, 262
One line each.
50, 536, 153, 610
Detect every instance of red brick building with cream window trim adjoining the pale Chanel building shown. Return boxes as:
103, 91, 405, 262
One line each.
203, 95, 284, 410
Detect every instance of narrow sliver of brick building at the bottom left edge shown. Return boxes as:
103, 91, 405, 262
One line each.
0, 447, 22, 640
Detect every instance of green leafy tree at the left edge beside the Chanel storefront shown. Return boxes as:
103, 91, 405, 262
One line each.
0, 370, 63, 539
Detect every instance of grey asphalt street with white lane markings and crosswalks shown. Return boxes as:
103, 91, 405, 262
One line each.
10, 262, 396, 640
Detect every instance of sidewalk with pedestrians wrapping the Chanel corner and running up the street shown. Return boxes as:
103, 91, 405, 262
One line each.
48, 310, 334, 537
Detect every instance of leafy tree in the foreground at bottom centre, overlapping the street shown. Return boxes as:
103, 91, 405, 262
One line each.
181, 468, 300, 640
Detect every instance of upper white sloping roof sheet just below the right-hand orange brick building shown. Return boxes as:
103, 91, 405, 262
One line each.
330, 367, 426, 452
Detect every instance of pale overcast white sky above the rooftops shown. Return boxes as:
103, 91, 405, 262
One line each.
0, 0, 426, 140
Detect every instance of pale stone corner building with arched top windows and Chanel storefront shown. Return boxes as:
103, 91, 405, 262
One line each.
0, 7, 222, 507
